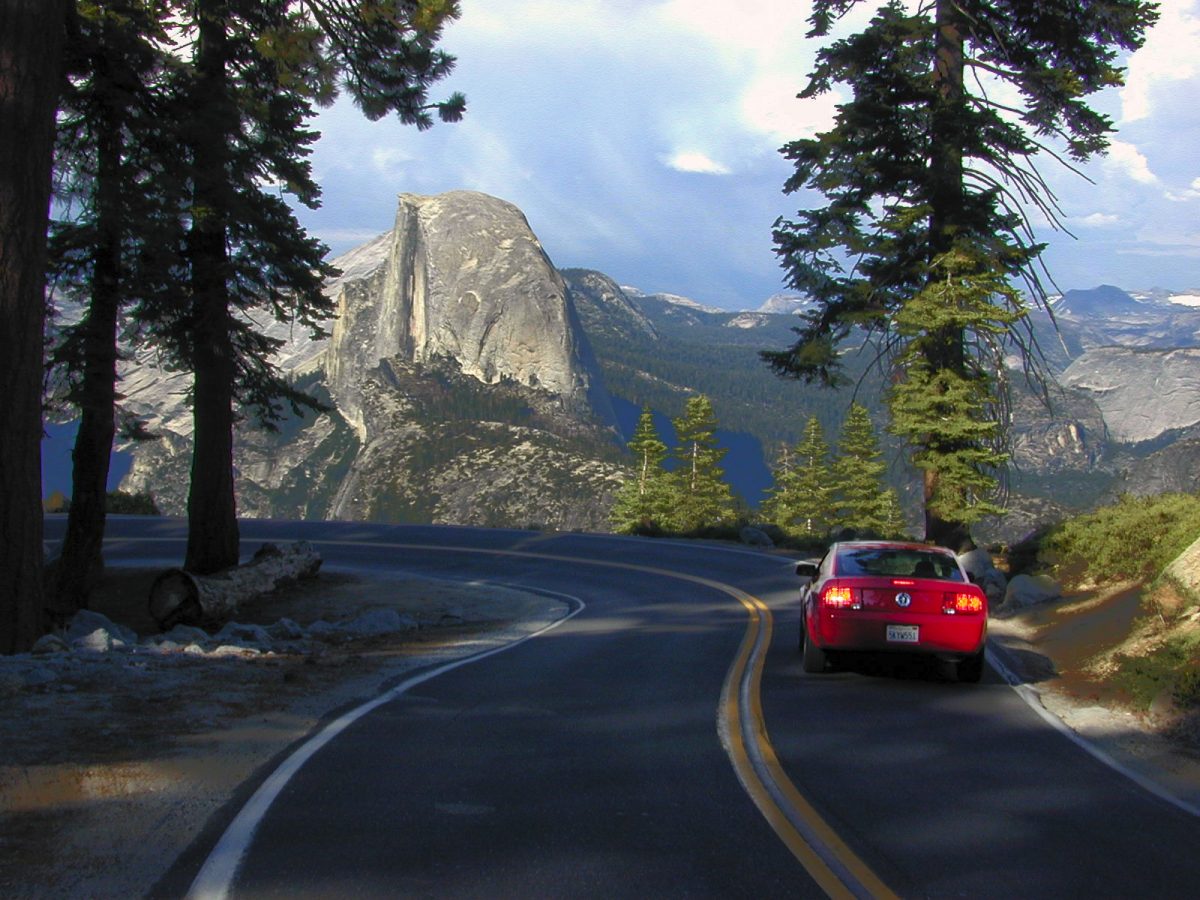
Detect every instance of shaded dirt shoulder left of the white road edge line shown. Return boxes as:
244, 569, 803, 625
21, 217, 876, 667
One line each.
0, 570, 565, 898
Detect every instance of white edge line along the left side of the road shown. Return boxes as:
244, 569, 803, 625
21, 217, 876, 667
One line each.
187, 582, 586, 900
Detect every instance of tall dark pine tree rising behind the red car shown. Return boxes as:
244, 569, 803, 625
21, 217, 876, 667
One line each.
763, 0, 1157, 544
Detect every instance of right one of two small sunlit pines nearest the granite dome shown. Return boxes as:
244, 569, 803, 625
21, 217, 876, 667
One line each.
671, 394, 733, 532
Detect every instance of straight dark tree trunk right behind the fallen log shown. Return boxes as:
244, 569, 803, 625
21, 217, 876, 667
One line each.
184, 0, 239, 575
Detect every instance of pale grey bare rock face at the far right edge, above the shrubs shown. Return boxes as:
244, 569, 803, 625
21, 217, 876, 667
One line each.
1061, 347, 1200, 444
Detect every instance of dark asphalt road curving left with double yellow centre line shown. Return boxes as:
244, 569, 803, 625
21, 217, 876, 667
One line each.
47, 517, 1200, 898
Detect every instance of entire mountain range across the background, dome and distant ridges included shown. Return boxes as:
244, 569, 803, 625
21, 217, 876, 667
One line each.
49, 192, 1200, 542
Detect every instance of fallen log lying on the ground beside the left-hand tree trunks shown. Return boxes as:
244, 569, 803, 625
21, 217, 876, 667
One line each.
150, 541, 322, 631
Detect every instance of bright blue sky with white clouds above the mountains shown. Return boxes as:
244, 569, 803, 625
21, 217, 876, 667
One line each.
288, 0, 1200, 310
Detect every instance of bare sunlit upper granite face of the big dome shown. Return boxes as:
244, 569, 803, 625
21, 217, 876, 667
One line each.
326, 191, 611, 433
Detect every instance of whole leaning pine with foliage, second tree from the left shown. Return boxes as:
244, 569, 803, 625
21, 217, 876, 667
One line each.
50, 0, 179, 619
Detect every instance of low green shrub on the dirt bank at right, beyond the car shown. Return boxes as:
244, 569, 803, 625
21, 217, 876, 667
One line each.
1039, 493, 1200, 583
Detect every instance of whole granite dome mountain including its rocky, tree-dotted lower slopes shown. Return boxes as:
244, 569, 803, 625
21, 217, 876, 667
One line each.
122, 192, 622, 529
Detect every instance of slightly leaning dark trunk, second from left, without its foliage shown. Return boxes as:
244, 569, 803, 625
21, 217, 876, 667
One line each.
53, 44, 127, 619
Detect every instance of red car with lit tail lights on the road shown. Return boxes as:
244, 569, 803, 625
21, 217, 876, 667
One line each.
796, 541, 988, 682
